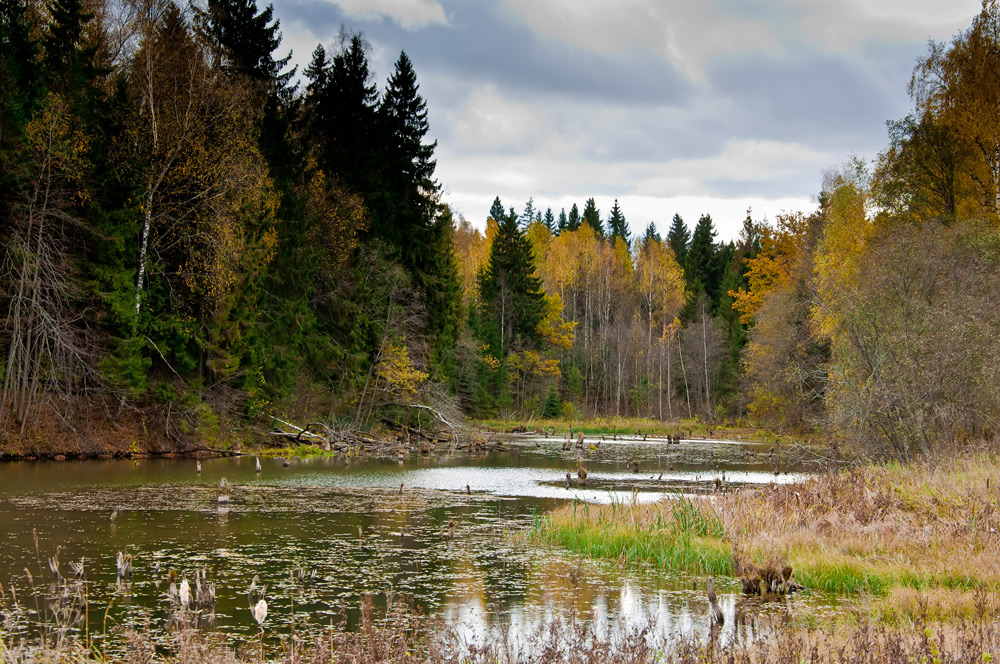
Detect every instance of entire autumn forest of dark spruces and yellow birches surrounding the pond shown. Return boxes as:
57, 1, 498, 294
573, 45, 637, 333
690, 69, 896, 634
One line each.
0, 0, 1000, 458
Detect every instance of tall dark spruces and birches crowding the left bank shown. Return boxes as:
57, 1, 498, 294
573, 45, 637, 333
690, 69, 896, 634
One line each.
0, 0, 460, 444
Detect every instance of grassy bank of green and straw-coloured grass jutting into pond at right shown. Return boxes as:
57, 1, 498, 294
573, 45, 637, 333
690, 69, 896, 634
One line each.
535, 454, 1000, 613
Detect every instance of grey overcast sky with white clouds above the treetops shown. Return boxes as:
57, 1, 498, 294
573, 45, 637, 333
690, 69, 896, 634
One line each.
274, 0, 980, 239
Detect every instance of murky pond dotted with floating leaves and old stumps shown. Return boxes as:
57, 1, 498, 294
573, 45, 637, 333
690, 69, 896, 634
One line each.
0, 436, 830, 656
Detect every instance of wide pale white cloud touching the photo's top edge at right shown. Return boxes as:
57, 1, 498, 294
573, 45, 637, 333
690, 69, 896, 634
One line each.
496, 0, 980, 82
